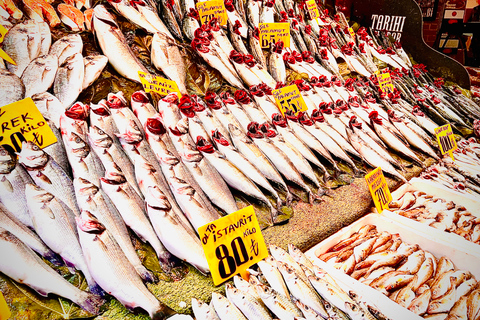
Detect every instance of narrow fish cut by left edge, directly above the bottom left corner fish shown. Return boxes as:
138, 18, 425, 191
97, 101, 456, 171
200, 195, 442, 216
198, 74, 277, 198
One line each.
0, 204, 62, 265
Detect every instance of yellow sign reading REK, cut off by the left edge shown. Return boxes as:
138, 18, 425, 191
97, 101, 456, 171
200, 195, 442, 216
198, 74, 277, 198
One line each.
0, 98, 57, 152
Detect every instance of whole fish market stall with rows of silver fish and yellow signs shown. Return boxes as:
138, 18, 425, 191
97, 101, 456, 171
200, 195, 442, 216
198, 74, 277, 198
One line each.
0, 0, 480, 320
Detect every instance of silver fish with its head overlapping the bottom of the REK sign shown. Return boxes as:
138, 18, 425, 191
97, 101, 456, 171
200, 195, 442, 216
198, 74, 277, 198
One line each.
18, 141, 80, 215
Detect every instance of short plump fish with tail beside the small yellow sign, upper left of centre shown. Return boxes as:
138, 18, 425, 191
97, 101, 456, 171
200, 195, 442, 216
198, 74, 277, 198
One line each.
151, 33, 187, 94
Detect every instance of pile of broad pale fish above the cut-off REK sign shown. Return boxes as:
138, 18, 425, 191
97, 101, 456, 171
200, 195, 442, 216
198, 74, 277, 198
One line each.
0, 20, 108, 109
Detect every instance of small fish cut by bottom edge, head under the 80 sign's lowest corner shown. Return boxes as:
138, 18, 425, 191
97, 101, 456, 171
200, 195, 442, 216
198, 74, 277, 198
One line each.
225, 283, 273, 320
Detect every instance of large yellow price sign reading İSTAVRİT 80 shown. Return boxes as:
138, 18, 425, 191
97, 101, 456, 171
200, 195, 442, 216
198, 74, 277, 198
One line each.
198, 206, 268, 286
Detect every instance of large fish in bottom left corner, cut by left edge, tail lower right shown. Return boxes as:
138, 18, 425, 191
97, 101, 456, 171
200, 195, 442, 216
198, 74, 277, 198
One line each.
0, 228, 104, 314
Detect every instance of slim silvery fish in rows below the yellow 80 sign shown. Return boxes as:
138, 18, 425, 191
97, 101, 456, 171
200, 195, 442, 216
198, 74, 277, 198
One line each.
192, 244, 386, 320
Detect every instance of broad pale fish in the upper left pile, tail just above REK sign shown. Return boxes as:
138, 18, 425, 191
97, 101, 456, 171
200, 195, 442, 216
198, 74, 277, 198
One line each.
21, 55, 58, 97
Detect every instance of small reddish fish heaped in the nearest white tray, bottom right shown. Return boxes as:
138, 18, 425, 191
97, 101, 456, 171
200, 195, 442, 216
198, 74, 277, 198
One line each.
318, 225, 480, 320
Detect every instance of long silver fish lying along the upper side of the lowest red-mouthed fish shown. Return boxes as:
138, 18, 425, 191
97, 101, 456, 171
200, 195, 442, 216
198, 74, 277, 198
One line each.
73, 178, 156, 282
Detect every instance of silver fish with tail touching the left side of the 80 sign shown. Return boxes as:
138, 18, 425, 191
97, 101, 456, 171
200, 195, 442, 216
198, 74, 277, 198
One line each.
145, 186, 210, 275
